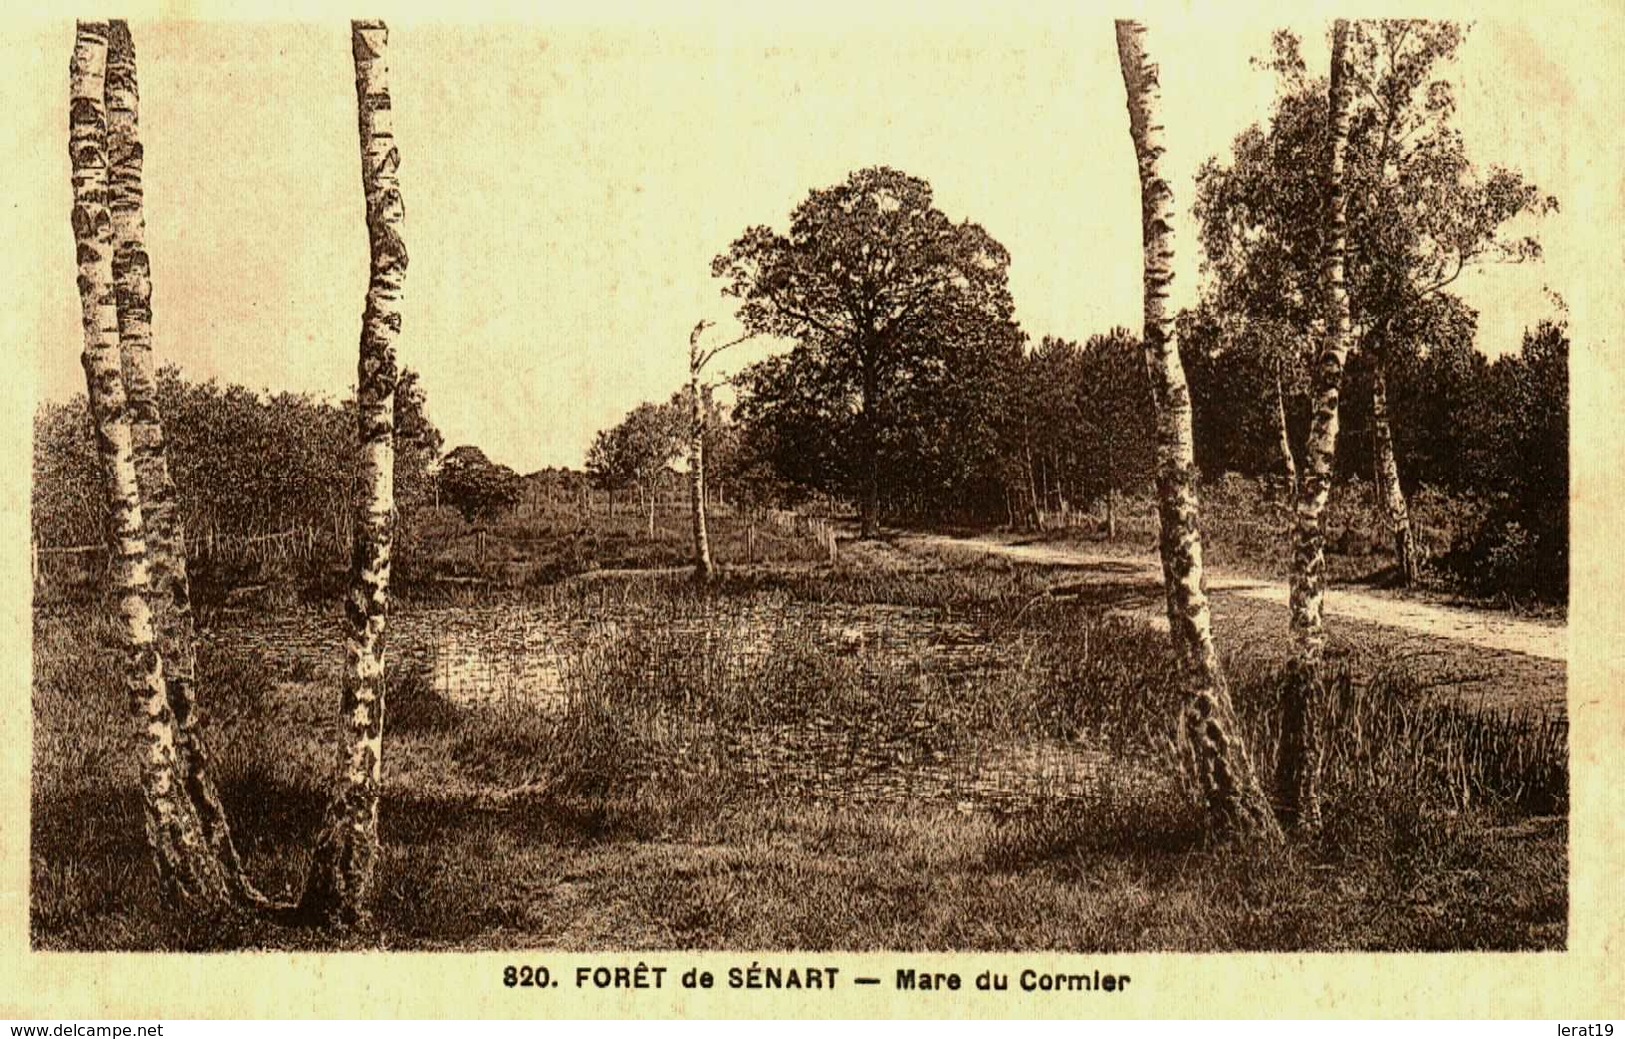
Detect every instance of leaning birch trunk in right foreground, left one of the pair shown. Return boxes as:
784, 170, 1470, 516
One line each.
1116, 21, 1281, 841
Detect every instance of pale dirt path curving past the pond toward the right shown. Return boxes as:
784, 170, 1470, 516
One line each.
900, 535, 1568, 662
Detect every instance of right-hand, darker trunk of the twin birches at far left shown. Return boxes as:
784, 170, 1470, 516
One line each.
106, 20, 260, 901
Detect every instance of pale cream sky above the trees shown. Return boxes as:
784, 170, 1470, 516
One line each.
9, 7, 1619, 470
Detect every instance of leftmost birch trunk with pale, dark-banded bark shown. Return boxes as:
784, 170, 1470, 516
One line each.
68, 21, 229, 909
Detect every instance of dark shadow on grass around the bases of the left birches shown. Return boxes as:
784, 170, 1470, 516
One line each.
31, 764, 715, 951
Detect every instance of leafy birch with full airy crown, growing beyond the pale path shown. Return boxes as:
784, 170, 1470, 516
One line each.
1196, 20, 1557, 584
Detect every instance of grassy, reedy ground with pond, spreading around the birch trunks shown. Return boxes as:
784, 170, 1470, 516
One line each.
31, 546, 1567, 950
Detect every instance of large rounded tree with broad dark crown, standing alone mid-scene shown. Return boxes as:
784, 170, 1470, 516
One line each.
712, 166, 1022, 532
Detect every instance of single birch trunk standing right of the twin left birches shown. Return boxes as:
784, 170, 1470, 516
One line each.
302, 21, 406, 925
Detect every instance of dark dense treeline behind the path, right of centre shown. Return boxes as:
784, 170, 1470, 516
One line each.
588, 289, 1570, 602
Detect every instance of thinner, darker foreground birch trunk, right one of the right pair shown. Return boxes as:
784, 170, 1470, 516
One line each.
1277, 18, 1350, 829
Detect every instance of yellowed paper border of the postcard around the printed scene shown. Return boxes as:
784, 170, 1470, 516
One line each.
0, 0, 1625, 1019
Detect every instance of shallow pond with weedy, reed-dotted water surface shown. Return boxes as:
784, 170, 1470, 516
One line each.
213, 598, 1167, 813
